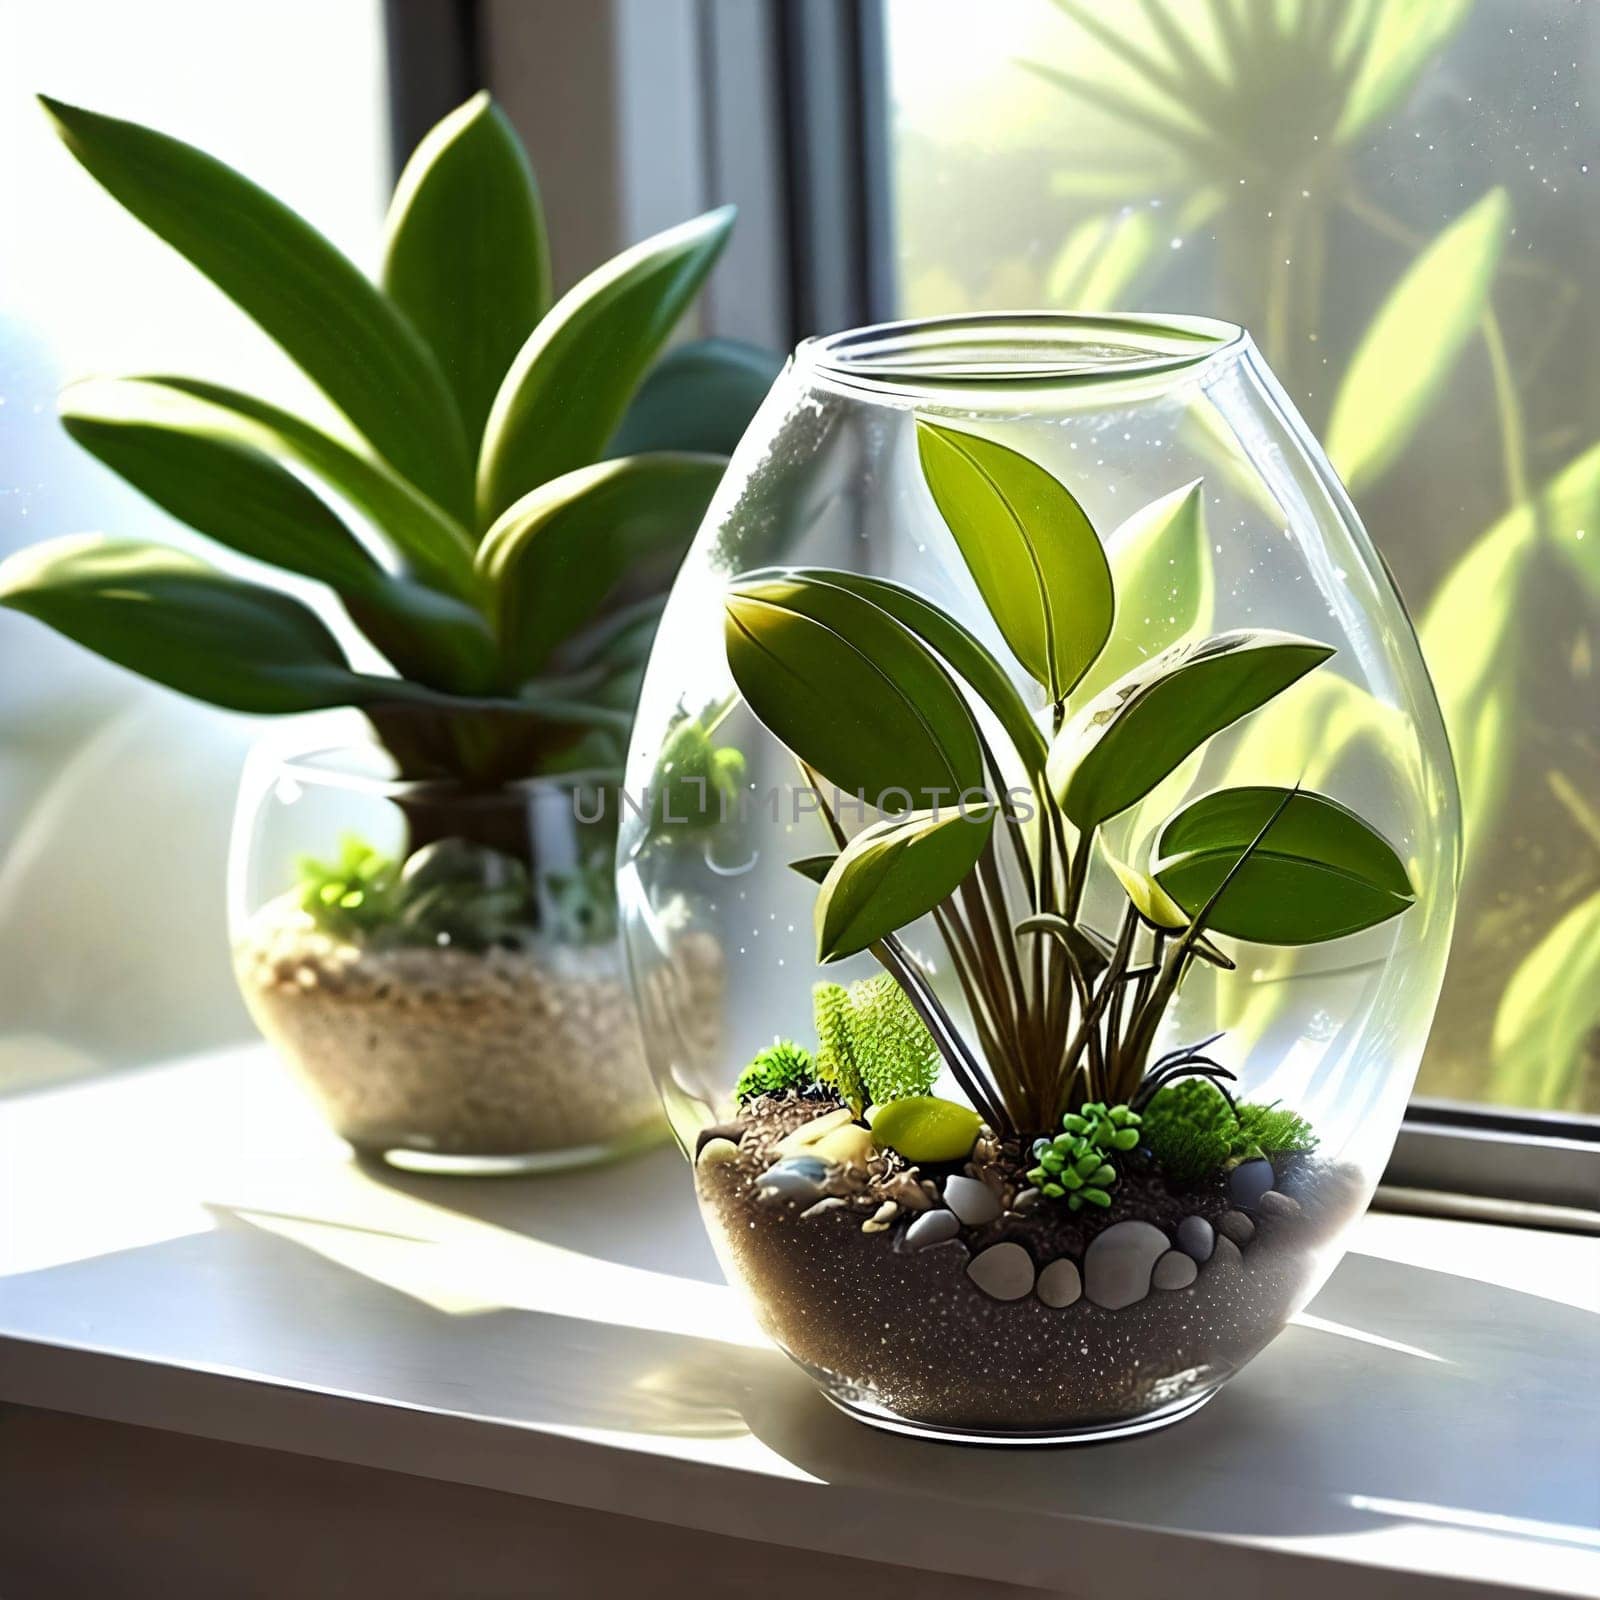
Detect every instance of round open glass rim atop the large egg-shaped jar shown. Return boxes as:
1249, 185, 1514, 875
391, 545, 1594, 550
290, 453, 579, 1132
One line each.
794, 310, 1250, 400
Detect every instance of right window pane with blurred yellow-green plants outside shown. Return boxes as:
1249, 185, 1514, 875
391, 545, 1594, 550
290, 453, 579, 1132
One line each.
886, 0, 1600, 1114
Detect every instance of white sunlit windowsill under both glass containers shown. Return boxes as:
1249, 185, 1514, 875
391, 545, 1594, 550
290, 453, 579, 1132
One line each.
0, 1048, 1600, 1600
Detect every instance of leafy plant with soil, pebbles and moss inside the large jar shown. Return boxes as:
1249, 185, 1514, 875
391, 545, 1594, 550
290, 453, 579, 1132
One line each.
696, 418, 1414, 1437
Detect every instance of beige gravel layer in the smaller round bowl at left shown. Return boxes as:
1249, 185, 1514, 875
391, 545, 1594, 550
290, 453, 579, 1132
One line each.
235, 904, 722, 1157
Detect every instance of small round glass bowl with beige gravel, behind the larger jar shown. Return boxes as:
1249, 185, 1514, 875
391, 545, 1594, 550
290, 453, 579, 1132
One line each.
229, 723, 717, 1173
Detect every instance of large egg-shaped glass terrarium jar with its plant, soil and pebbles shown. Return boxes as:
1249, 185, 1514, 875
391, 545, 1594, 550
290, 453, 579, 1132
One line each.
619, 315, 1459, 1442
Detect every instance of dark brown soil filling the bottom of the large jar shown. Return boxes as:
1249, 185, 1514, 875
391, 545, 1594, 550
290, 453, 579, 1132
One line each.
698, 1098, 1365, 1430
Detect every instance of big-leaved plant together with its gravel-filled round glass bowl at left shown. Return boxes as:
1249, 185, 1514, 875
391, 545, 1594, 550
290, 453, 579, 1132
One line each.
0, 94, 776, 1162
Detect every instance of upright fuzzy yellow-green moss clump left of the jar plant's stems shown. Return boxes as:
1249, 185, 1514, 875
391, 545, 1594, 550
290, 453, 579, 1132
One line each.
811, 973, 939, 1115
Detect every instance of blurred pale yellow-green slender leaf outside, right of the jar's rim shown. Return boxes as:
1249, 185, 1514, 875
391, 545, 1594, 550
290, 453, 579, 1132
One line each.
1328, 189, 1510, 494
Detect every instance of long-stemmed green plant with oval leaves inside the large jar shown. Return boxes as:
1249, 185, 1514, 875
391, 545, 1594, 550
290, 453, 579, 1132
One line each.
725, 419, 1414, 1133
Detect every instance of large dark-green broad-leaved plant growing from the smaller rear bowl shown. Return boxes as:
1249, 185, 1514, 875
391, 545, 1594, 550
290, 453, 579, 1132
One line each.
0, 94, 776, 889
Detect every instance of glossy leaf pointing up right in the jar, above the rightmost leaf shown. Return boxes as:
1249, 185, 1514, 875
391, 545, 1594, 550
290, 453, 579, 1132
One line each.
1048, 629, 1333, 829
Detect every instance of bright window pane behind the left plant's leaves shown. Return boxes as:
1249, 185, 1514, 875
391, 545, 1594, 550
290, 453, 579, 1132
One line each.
0, 0, 389, 1091
